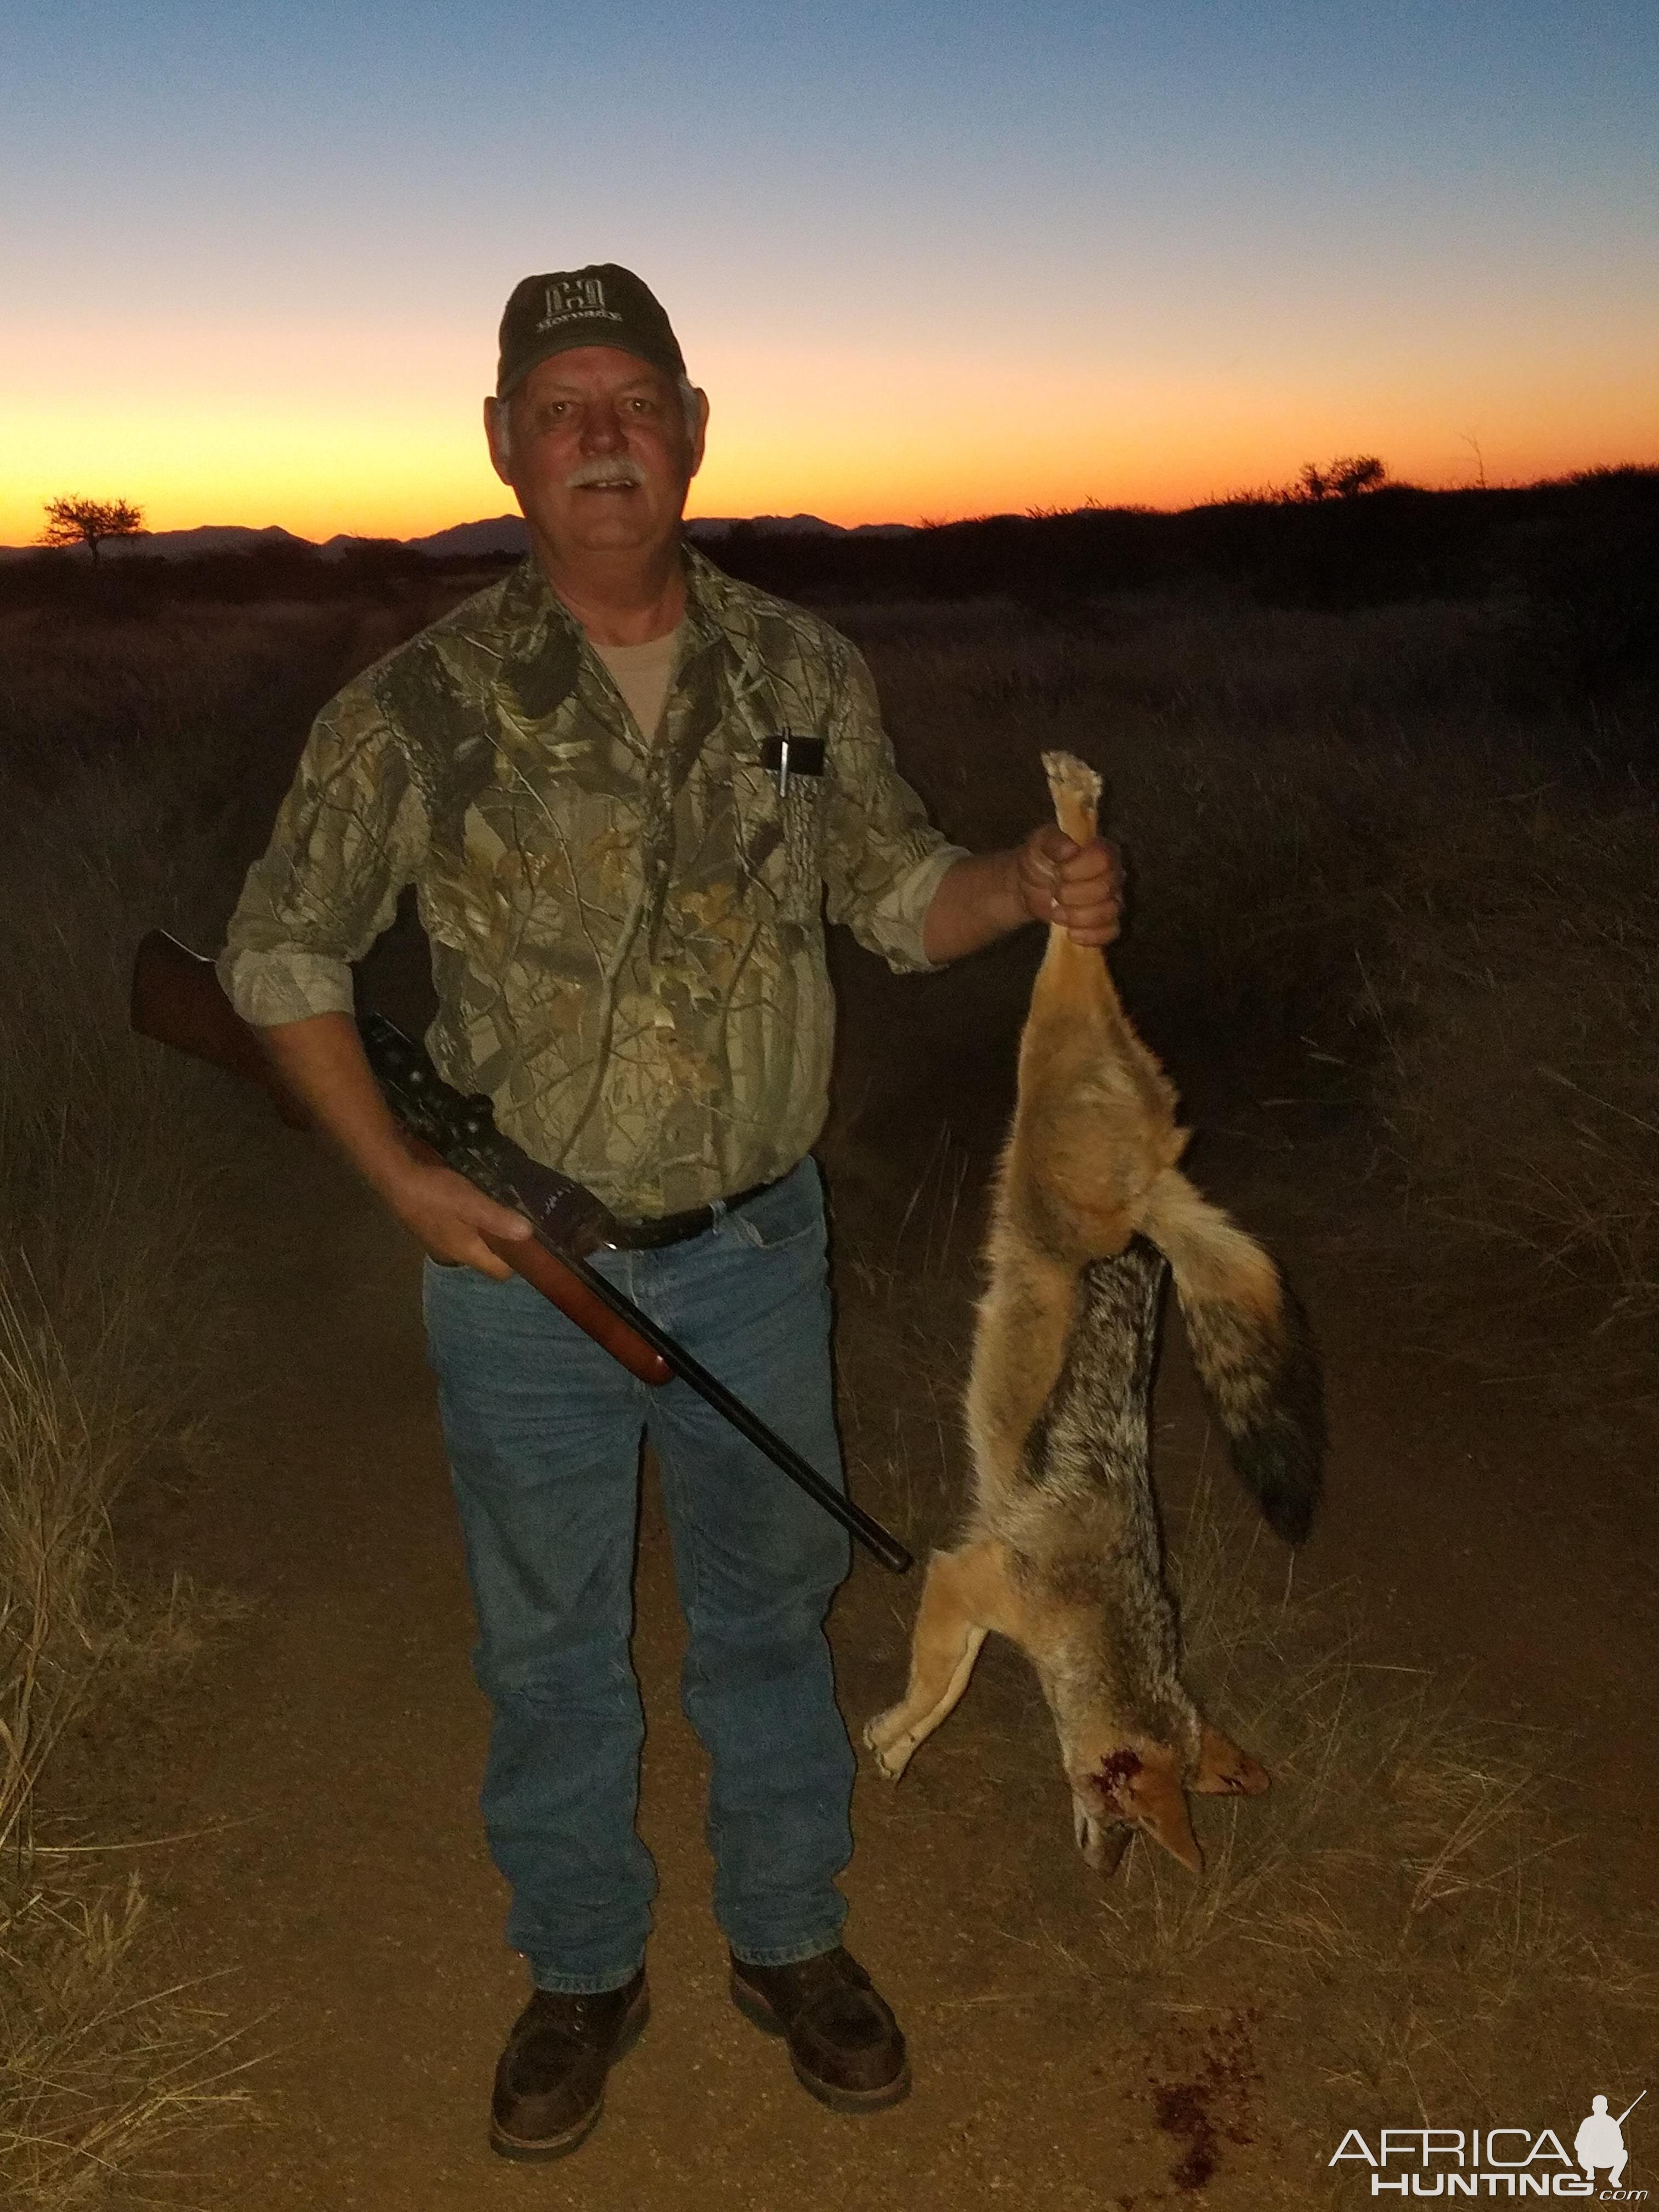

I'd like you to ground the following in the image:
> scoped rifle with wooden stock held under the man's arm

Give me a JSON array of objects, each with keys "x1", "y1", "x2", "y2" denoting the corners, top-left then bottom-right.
[{"x1": 133, "y1": 929, "x2": 913, "y2": 1575}]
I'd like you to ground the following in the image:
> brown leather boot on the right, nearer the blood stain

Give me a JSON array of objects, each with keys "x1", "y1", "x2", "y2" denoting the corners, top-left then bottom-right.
[{"x1": 732, "y1": 1944, "x2": 909, "y2": 2113}]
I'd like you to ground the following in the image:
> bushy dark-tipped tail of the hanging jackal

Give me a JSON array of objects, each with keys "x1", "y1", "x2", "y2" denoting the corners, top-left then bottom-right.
[{"x1": 1137, "y1": 1168, "x2": 1325, "y2": 1544}]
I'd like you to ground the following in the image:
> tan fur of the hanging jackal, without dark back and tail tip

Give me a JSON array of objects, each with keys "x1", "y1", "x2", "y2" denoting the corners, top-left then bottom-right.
[{"x1": 865, "y1": 754, "x2": 1309, "y2": 1871}]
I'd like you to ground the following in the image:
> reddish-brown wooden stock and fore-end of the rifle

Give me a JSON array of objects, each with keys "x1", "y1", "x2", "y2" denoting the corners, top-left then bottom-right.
[{"x1": 133, "y1": 929, "x2": 673, "y2": 1383}]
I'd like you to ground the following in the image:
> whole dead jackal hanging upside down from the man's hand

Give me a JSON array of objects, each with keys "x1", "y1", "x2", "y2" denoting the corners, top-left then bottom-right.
[{"x1": 865, "y1": 752, "x2": 1323, "y2": 1871}]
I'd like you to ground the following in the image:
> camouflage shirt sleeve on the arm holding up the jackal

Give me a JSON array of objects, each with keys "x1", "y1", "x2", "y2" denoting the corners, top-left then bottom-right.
[{"x1": 823, "y1": 650, "x2": 967, "y2": 973}]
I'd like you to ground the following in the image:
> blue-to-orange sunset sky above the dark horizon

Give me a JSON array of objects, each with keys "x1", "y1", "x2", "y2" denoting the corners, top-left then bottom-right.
[{"x1": 0, "y1": 0, "x2": 1659, "y2": 544}]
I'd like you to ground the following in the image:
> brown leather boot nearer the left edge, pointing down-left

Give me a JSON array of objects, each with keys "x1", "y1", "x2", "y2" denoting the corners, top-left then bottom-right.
[{"x1": 489, "y1": 1966, "x2": 650, "y2": 2159}]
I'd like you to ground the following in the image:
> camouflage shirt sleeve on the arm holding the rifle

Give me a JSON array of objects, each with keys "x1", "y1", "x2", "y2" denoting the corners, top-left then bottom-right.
[{"x1": 219, "y1": 684, "x2": 427, "y2": 1029}]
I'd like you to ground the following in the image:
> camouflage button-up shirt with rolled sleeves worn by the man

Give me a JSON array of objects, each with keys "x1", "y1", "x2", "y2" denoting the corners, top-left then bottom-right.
[{"x1": 219, "y1": 549, "x2": 960, "y2": 1217}]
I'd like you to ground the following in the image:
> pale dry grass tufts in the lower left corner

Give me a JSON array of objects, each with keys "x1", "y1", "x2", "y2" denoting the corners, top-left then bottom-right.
[{"x1": 0, "y1": 1252, "x2": 253, "y2": 2212}]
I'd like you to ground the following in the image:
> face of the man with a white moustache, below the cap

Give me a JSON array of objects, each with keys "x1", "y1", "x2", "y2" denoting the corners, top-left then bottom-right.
[{"x1": 484, "y1": 345, "x2": 708, "y2": 557}]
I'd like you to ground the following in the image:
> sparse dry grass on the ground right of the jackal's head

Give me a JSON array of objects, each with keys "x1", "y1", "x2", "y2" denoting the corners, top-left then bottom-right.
[{"x1": 1104, "y1": 1477, "x2": 1659, "y2": 2168}]
